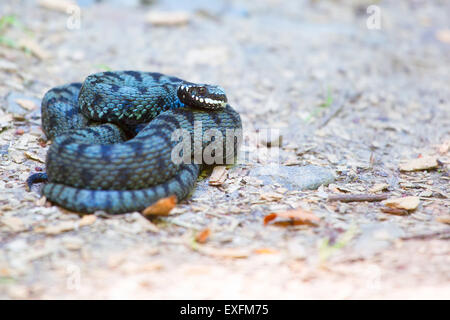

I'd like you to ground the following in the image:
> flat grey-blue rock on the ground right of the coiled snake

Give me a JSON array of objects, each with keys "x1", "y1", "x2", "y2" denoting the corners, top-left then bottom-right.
[{"x1": 250, "y1": 164, "x2": 335, "y2": 191}]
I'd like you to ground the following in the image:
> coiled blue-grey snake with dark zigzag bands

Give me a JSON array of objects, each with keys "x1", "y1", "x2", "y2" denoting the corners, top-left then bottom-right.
[{"x1": 27, "y1": 70, "x2": 242, "y2": 214}]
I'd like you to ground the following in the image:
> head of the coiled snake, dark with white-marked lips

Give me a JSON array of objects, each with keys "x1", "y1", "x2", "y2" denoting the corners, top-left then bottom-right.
[{"x1": 177, "y1": 83, "x2": 227, "y2": 110}]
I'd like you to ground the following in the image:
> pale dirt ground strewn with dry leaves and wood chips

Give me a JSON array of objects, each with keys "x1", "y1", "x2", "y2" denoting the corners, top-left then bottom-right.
[{"x1": 0, "y1": 0, "x2": 450, "y2": 299}]
